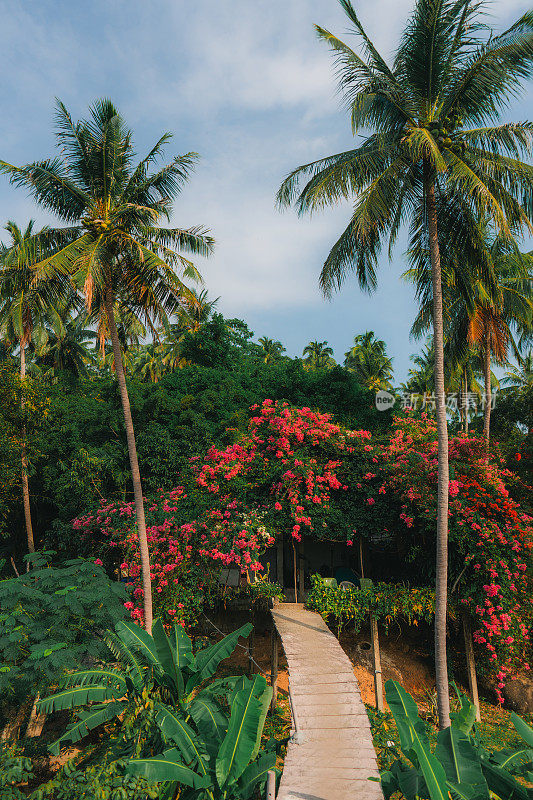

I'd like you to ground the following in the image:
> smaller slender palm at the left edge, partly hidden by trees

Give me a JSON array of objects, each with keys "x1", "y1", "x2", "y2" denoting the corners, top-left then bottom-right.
[{"x1": 0, "y1": 220, "x2": 69, "y2": 553}]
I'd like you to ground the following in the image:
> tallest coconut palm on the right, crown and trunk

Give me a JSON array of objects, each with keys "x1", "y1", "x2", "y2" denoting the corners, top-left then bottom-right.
[{"x1": 278, "y1": 0, "x2": 533, "y2": 728}]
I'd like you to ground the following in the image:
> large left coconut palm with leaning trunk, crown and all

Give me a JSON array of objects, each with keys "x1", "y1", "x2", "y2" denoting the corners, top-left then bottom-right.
[{"x1": 0, "y1": 99, "x2": 213, "y2": 630}]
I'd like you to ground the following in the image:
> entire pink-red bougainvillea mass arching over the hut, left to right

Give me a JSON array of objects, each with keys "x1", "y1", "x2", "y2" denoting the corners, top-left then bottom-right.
[{"x1": 75, "y1": 400, "x2": 533, "y2": 699}]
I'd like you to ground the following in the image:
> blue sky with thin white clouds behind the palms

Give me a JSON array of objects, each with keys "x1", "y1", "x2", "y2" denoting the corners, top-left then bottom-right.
[{"x1": 0, "y1": 0, "x2": 533, "y2": 382}]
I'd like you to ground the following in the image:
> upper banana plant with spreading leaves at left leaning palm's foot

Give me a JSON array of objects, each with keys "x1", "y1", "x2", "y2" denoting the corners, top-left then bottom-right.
[{"x1": 37, "y1": 620, "x2": 252, "y2": 758}]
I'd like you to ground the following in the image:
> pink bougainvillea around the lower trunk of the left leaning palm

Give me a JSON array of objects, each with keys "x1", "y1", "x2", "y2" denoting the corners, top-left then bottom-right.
[{"x1": 73, "y1": 487, "x2": 273, "y2": 625}]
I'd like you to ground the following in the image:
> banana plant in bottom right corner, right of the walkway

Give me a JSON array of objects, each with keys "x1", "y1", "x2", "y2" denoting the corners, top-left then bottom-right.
[{"x1": 381, "y1": 681, "x2": 533, "y2": 800}]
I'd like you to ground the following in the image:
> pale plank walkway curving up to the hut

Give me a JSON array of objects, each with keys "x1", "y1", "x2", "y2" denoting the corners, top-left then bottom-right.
[{"x1": 272, "y1": 603, "x2": 383, "y2": 800}]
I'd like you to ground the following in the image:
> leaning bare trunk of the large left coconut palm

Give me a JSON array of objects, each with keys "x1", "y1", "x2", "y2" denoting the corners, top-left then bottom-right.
[{"x1": 104, "y1": 290, "x2": 152, "y2": 633}]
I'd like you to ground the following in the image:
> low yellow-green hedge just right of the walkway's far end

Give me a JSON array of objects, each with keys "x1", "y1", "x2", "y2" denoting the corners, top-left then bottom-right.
[{"x1": 306, "y1": 575, "x2": 435, "y2": 632}]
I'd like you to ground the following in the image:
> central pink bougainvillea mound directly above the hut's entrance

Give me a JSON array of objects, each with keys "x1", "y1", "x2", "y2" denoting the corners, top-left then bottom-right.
[{"x1": 194, "y1": 400, "x2": 377, "y2": 541}]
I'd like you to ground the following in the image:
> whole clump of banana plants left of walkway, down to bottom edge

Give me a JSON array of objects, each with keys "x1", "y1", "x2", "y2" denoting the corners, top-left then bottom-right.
[{"x1": 39, "y1": 620, "x2": 276, "y2": 800}]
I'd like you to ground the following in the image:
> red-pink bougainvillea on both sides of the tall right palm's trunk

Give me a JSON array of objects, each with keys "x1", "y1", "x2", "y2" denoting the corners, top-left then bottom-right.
[{"x1": 382, "y1": 415, "x2": 533, "y2": 702}]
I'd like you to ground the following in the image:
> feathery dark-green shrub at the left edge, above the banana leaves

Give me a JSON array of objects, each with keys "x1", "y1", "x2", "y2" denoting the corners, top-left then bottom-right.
[{"x1": 0, "y1": 552, "x2": 125, "y2": 702}]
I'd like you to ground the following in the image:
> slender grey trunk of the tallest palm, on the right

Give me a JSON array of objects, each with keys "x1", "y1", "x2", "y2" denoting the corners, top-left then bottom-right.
[{"x1": 424, "y1": 170, "x2": 450, "y2": 730}]
